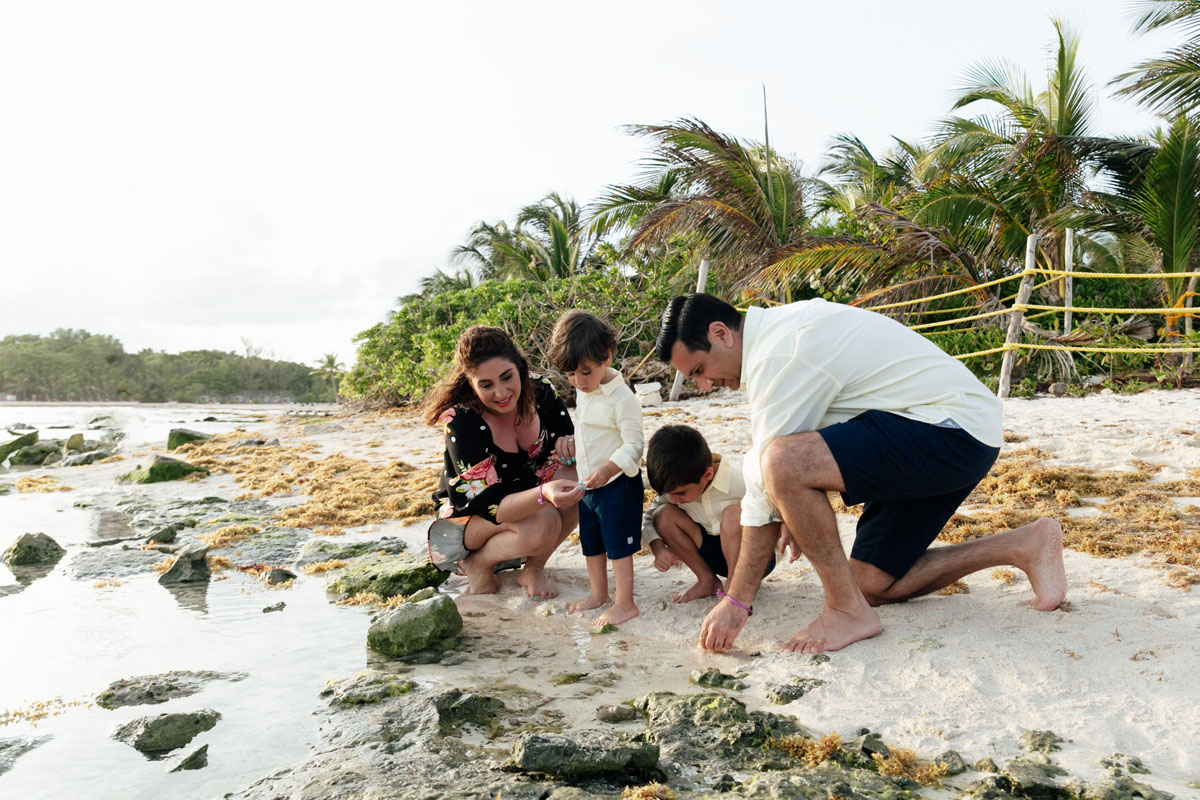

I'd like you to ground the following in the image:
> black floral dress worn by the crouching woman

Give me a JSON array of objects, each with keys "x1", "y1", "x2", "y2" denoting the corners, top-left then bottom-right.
[{"x1": 433, "y1": 378, "x2": 575, "y2": 523}]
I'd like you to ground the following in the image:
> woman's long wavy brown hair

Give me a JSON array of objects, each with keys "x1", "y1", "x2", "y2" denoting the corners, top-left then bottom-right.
[{"x1": 421, "y1": 325, "x2": 534, "y2": 425}]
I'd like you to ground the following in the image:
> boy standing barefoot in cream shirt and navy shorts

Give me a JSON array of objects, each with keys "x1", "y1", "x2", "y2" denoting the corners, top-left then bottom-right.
[{"x1": 550, "y1": 311, "x2": 646, "y2": 625}]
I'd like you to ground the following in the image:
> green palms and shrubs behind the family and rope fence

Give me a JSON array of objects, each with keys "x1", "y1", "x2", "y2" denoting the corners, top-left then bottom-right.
[{"x1": 350, "y1": 0, "x2": 1200, "y2": 404}]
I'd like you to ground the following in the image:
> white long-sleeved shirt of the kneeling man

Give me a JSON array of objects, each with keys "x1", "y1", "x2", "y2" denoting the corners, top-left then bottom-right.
[{"x1": 742, "y1": 300, "x2": 1003, "y2": 527}]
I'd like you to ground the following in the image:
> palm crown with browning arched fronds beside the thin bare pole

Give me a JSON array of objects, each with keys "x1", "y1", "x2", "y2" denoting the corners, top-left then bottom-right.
[{"x1": 592, "y1": 119, "x2": 812, "y2": 292}]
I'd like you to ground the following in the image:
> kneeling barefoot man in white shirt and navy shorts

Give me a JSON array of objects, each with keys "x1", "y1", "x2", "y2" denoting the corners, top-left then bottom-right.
[{"x1": 655, "y1": 294, "x2": 1067, "y2": 652}]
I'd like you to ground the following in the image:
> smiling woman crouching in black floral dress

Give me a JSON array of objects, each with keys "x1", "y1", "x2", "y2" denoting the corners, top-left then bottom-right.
[{"x1": 422, "y1": 325, "x2": 583, "y2": 600}]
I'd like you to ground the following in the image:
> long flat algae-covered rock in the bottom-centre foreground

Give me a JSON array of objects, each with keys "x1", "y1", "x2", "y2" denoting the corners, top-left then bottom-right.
[{"x1": 512, "y1": 733, "x2": 659, "y2": 778}]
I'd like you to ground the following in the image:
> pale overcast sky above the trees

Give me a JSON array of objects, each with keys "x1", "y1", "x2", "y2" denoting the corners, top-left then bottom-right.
[{"x1": 0, "y1": 0, "x2": 1176, "y2": 366}]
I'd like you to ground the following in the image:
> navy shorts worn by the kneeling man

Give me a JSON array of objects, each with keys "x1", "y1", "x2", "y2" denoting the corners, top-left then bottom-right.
[{"x1": 817, "y1": 411, "x2": 1000, "y2": 579}]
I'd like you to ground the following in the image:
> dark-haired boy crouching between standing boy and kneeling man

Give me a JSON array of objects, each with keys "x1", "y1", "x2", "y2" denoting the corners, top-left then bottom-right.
[{"x1": 642, "y1": 425, "x2": 777, "y2": 603}]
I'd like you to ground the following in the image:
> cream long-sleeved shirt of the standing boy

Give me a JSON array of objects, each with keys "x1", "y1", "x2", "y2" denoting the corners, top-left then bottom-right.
[{"x1": 575, "y1": 367, "x2": 646, "y2": 486}]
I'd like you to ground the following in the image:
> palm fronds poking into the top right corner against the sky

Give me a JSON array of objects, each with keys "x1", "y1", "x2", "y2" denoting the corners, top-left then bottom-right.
[{"x1": 1112, "y1": 0, "x2": 1200, "y2": 115}]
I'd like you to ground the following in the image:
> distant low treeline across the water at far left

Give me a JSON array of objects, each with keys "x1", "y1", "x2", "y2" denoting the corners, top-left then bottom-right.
[{"x1": 0, "y1": 329, "x2": 334, "y2": 403}]
